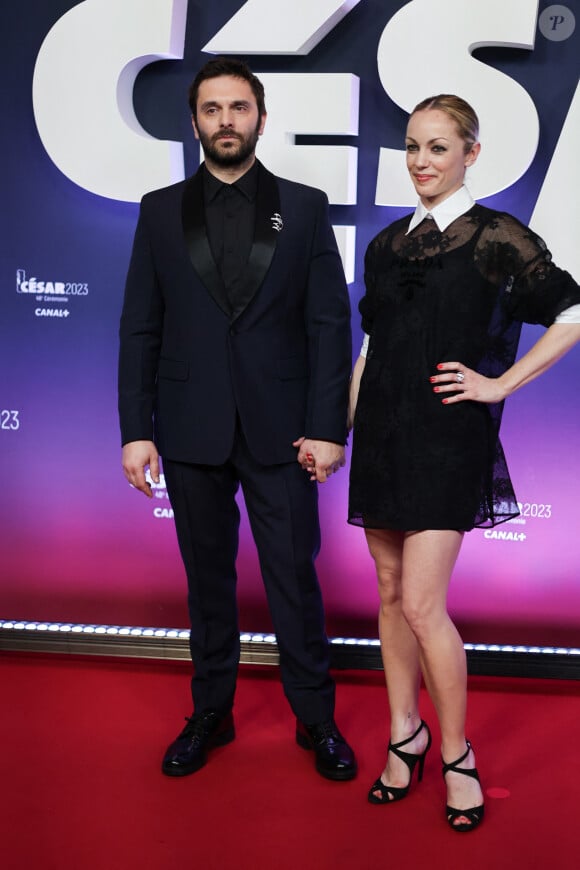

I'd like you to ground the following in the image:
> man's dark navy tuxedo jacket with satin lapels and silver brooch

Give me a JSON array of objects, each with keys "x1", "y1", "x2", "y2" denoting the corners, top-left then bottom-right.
[{"x1": 119, "y1": 165, "x2": 352, "y2": 465}]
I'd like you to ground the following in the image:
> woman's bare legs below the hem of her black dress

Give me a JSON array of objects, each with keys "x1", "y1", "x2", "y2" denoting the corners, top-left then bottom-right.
[{"x1": 366, "y1": 529, "x2": 482, "y2": 824}]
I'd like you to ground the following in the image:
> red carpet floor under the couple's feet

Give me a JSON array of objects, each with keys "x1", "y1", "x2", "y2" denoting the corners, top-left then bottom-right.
[{"x1": 0, "y1": 653, "x2": 580, "y2": 870}]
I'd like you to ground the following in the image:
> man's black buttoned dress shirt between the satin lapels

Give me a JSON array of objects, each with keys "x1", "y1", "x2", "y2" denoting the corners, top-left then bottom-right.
[{"x1": 203, "y1": 163, "x2": 258, "y2": 302}]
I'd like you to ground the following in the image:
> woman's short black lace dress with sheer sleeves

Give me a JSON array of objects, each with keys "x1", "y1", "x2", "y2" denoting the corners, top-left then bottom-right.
[{"x1": 349, "y1": 205, "x2": 580, "y2": 530}]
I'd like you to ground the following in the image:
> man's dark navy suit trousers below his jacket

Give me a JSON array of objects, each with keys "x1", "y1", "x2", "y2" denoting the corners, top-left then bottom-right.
[{"x1": 163, "y1": 426, "x2": 334, "y2": 724}]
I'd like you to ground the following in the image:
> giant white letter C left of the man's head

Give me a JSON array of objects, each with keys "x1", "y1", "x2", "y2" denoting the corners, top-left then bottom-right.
[{"x1": 32, "y1": 0, "x2": 187, "y2": 202}]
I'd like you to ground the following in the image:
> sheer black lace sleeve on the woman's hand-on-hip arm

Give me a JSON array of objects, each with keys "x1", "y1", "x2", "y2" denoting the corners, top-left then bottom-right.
[{"x1": 475, "y1": 213, "x2": 580, "y2": 326}]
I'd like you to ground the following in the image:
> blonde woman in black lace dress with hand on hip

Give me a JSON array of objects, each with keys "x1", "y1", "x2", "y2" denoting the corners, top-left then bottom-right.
[{"x1": 349, "y1": 94, "x2": 580, "y2": 832}]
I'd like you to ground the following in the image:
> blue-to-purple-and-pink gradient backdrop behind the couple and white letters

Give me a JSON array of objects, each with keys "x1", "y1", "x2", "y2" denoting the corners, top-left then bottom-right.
[{"x1": 0, "y1": 0, "x2": 580, "y2": 645}]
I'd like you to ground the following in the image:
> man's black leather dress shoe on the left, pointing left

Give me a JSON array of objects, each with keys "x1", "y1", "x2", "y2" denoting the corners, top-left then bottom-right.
[{"x1": 161, "y1": 712, "x2": 236, "y2": 776}]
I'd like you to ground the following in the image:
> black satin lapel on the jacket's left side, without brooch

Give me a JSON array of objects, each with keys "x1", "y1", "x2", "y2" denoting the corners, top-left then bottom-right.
[{"x1": 181, "y1": 170, "x2": 232, "y2": 317}]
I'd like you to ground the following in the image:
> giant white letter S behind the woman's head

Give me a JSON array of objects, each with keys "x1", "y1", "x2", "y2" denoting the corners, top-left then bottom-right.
[{"x1": 375, "y1": 0, "x2": 539, "y2": 206}]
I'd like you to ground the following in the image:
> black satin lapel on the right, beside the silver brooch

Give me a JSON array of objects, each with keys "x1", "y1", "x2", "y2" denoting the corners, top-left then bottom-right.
[{"x1": 232, "y1": 164, "x2": 283, "y2": 320}]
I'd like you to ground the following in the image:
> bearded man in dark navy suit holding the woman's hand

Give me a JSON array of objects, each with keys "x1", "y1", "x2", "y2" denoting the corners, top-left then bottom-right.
[{"x1": 119, "y1": 58, "x2": 356, "y2": 780}]
